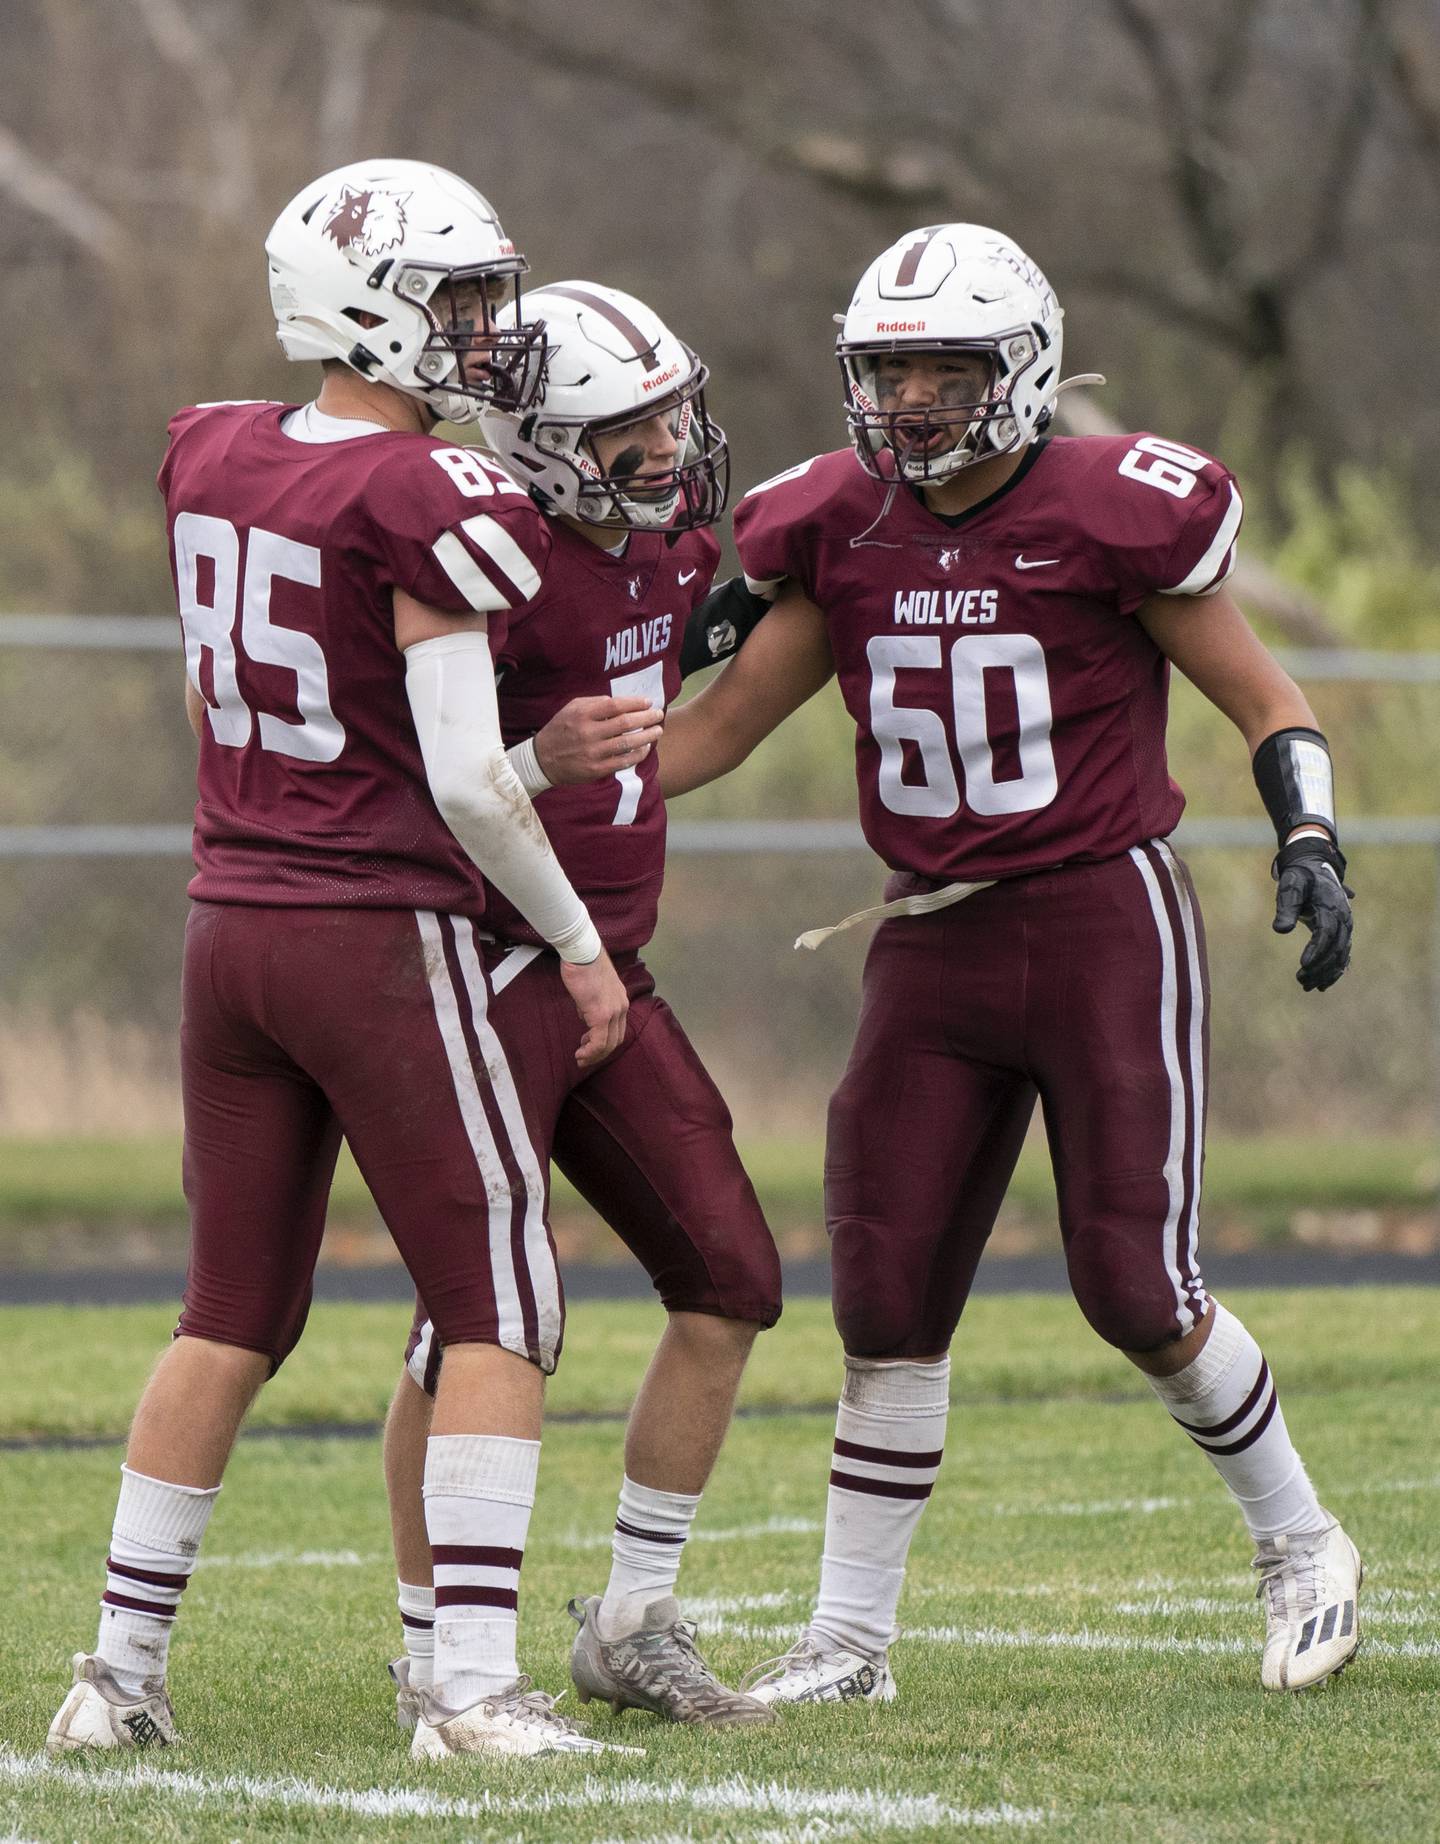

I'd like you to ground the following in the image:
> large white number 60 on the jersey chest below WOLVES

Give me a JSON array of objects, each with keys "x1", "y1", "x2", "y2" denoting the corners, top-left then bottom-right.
[{"x1": 865, "y1": 634, "x2": 1060, "y2": 819}]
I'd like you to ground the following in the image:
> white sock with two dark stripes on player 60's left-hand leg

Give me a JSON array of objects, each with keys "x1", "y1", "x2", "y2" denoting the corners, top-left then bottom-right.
[{"x1": 811, "y1": 1357, "x2": 950, "y2": 1652}]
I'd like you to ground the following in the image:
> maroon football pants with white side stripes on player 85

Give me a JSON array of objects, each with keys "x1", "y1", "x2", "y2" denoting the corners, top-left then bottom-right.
[{"x1": 179, "y1": 904, "x2": 578, "y2": 1370}]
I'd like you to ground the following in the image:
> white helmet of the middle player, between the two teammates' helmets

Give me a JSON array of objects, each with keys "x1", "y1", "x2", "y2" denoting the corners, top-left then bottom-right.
[{"x1": 479, "y1": 282, "x2": 730, "y2": 531}]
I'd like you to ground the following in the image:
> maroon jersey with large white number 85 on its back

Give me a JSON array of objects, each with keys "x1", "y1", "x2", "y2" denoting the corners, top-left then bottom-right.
[{"x1": 160, "y1": 404, "x2": 549, "y2": 916}]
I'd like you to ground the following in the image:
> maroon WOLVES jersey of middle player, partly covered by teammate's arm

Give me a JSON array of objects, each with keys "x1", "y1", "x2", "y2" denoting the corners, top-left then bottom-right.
[{"x1": 487, "y1": 524, "x2": 719, "y2": 953}]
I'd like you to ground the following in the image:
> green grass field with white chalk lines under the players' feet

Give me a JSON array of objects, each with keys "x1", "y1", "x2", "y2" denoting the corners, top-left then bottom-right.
[{"x1": 0, "y1": 1289, "x2": 1440, "y2": 1844}]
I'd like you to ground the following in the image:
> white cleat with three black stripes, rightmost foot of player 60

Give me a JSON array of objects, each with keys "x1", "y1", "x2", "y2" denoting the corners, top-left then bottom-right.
[{"x1": 1254, "y1": 1521, "x2": 1364, "y2": 1691}]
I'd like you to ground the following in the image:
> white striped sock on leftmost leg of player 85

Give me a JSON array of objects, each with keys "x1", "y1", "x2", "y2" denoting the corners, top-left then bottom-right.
[{"x1": 96, "y1": 1466, "x2": 219, "y2": 1696}]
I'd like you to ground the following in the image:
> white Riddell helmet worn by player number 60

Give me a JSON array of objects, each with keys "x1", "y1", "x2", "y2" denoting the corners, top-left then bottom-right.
[{"x1": 835, "y1": 225, "x2": 1079, "y2": 481}]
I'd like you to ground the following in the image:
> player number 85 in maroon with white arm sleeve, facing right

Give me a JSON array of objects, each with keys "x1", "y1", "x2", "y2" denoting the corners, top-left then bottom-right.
[{"x1": 48, "y1": 160, "x2": 643, "y2": 1755}]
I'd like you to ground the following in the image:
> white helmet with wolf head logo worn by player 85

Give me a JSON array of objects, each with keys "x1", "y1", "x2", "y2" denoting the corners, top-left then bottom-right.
[{"x1": 266, "y1": 160, "x2": 546, "y2": 422}]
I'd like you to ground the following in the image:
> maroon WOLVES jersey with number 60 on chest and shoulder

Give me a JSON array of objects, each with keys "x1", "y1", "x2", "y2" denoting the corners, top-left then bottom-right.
[{"x1": 734, "y1": 435, "x2": 1243, "y2": 881}]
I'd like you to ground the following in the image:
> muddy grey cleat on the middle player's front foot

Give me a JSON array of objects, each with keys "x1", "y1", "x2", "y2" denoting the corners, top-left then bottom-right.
[{"x1": 570, "y1": 1595, "x2": 774, "y2": 1728}]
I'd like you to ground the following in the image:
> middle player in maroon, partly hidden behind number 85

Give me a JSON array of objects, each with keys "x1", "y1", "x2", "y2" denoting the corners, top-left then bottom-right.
[{"x1": 376, "y1": 282, "x2": 780, "y2": 1726}]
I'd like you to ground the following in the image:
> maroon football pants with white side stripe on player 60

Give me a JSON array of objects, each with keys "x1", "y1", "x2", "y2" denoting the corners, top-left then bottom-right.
[{"x1": 826, "y1": 843, "x2": 1210, "y2": 1357}]
